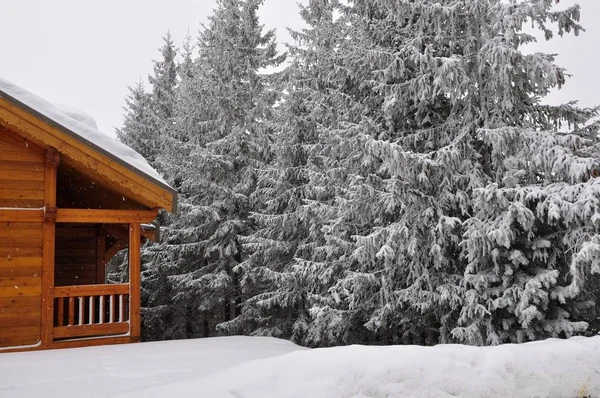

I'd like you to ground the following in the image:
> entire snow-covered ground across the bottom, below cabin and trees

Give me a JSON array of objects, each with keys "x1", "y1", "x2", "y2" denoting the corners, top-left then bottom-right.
[{"x1": 0, "y1": 337, "x2": 600, "y2": 398}]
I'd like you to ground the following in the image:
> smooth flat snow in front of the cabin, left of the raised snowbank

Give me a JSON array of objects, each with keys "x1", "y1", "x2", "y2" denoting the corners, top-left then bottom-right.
[{"x1": 0, "y1": 337, "x2": 301, "y2": 398}]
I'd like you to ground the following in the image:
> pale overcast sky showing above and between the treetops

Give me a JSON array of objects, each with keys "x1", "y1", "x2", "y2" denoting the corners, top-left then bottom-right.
[{"x1": 0, "y1": 0, "x2": 600, "y2": 132}]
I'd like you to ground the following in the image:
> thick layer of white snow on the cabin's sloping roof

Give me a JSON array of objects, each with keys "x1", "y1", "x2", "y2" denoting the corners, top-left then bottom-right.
[{"x1": 0, "y1": 78, "x2": 172, "y2": 190}]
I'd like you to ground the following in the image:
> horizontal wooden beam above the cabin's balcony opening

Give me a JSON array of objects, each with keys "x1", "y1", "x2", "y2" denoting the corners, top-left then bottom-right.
[{"x1": 56, "y1": 209, "x2": 158, "y2": 224}]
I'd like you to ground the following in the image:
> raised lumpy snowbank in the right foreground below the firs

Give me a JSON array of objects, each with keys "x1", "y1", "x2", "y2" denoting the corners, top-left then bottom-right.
[{"x1": 125, "y1": 337, "x2": 600, "y2": 398}]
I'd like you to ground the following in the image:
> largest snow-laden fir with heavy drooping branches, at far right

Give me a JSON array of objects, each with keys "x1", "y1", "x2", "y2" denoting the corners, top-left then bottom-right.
[{"x1": 332, "y1": 0, "x2": 598, "y2": 344}]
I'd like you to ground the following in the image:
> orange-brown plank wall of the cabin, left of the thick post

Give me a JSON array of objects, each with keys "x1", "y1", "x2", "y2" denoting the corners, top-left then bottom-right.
[{"x1": 0, "y1": 128, "x2": 46, "y2": 348}]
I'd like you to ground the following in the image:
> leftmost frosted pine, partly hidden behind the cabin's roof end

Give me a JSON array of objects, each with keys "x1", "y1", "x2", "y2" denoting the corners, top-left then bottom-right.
[{"x1": 117, "y1": 33, "x2": 186, "y2": 340}]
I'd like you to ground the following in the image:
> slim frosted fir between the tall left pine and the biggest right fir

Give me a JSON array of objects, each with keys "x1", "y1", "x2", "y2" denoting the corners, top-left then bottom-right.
[{"x1": 221, "y1": 1, "x2": 350, "y2": 344}]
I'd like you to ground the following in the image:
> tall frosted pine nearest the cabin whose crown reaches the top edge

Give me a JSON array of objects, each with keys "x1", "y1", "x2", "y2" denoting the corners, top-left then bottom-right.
[{"x1": 160, "y1": 0, "x2": 284, "y2": 334}]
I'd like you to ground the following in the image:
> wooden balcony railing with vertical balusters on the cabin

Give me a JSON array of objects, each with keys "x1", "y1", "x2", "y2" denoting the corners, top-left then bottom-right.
[{"x1": 53, "y1": 283, "x2": 130, "y2": 339}]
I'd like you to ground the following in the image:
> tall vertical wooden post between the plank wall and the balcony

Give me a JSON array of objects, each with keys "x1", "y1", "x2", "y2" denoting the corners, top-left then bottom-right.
[{"x1": 41, "y1": 148, "x2": 60, "y2": 347}]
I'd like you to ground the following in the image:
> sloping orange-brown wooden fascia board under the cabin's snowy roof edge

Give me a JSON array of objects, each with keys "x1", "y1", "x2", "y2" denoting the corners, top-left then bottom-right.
[{"x1": 0, "y1": 98, "x2": 174, "y2": 211}]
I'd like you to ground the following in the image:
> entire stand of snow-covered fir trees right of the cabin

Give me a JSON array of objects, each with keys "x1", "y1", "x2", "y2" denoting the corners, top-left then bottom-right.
[{"x1": 117, "y1": 0, "x2": 600, "y2": 346}]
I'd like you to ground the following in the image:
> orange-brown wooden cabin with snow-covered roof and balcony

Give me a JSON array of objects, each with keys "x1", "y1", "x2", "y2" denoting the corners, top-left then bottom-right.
[{"x1": 0, "y1": 79, "x2": 176, "y2": 353}]
